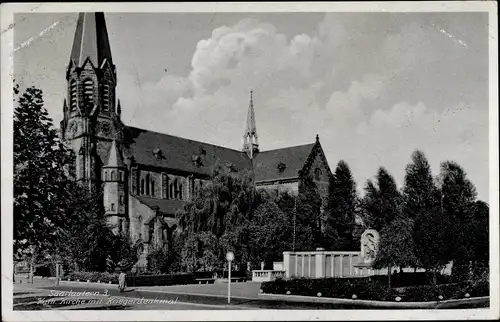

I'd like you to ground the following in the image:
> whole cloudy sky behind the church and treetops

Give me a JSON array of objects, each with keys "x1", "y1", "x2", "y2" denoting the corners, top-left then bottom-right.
[{"x1": 14, "y1": 13, "x2": 489, "y2": 201}]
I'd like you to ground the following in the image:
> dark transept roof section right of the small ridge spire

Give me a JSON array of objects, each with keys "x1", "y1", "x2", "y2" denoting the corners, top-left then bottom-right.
[{"x1": 253, "y1": 143, "x2": 315, "y2": 183}]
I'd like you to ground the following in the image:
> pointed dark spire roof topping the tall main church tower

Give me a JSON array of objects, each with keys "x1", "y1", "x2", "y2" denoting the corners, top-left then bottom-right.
[{"x1": 70, "y1": 12, "x2": 113, "y2": 68}]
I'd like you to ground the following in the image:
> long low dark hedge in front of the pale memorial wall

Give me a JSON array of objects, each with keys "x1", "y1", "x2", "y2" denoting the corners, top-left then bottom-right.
[{"x1": 261, "y1": 277, "x2": 489, "y2": 302}]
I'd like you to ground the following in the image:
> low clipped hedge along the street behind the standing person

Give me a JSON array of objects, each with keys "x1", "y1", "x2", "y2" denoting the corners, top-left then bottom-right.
[{"x1": 63, "y1": 272, "x2": 196, "y2": 286}]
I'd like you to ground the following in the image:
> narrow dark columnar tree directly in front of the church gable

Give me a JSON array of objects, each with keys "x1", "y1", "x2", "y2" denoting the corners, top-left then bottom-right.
[{"x1": 294, "y1": 176, "x2": 321, "y2": 250}]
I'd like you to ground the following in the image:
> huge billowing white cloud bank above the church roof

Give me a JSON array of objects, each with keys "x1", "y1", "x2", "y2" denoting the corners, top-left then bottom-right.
[{"x1": 112, "y1": 15, "x2": 488, "y2": 200}]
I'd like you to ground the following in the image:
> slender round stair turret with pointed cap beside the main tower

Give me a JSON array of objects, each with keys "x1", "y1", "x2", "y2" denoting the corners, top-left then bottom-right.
[{"x1": 102, "y1": 140, "x2": 128, "y2": 233}]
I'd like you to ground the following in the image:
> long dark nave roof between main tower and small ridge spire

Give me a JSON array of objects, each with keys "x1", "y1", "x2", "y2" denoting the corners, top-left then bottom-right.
[{"x1": 124, "y1": 126, "x2": 252, "y2": 176}]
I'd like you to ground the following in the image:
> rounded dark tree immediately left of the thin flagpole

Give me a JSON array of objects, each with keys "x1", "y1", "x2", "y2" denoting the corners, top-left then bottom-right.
[{"x1": 250, "y1": 200, "x2": 293, "y2": 265}]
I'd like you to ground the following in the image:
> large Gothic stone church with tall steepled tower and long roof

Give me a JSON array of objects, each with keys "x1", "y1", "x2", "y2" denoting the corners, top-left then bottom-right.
[{"x1": 60, "y1": 13, "x2": 332, "y2": 265}]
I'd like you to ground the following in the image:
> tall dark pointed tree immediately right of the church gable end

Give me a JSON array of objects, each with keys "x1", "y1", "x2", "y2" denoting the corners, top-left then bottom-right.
[{"x1": 325, "y1": 160, "x2": 359, "y2": 250}]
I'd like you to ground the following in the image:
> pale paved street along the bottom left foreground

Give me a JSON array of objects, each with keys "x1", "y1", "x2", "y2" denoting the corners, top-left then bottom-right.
[{"x1": 10, "y1": 280, "x2": 356, "y2": 310}]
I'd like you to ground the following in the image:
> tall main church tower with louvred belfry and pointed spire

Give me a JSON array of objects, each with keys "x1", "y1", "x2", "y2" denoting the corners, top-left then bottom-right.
[{"x1": 61, "y1": 12, "x2": 122, "y2": 188}]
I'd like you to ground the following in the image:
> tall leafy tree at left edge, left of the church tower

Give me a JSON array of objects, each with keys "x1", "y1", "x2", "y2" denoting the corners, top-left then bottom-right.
[{"x1": 13, "y1": 86, "x2": 73, "y2": 275}]
